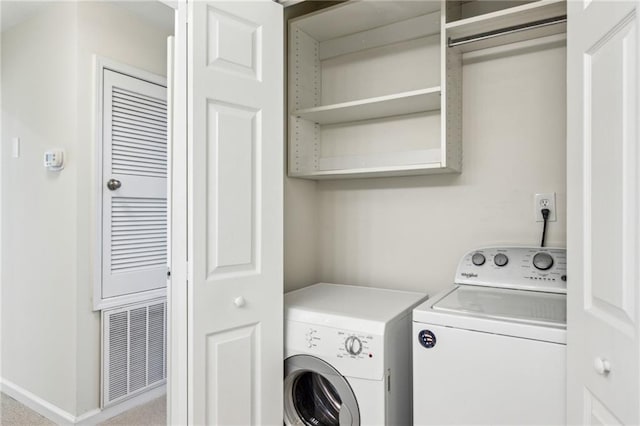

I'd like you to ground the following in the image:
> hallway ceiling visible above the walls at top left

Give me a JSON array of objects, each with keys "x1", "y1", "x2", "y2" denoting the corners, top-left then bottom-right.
[{"x1": 0, "y1": 0, "x2": 174, "y2": 32}]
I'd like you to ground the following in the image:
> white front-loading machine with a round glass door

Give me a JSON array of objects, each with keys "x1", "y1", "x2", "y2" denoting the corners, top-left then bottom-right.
[{"x1": 284, "y1": 283, "x2": 427, "y2": 426}]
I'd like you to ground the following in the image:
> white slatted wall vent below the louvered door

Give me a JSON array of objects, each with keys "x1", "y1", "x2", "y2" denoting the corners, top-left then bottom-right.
[{"x1": 102, "y1": 298, "x2": 167, "y2": 407}]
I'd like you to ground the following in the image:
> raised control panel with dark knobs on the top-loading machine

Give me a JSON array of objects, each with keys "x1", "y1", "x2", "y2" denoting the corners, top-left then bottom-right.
[{"x1": 455, "y1": 247, "x2": 567, "y2": 293}]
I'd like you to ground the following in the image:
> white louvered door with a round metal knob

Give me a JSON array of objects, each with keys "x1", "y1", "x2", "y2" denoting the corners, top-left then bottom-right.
[{"x1": 102, "y1": 69, "x2": 167, "y2": 300}]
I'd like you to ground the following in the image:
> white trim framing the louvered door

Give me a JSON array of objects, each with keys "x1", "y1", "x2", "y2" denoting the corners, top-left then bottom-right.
[{"x1": 92, "y1": 54, "x2": 168, "y2": 311}]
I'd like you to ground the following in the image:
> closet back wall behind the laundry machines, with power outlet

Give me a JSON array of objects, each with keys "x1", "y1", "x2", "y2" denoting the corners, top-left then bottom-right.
[{"x1": 285, "y1": 38, "x2": 566, "y2": 294}]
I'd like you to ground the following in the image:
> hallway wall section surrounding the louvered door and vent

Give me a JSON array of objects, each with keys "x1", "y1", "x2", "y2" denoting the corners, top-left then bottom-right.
[{"x1": 76, "y1": 1, "x2": 171, "y2": 414}]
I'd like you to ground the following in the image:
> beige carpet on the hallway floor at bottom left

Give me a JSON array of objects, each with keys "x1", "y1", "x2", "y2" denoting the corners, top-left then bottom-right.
[{"x1": 0, "y1": 393, "x2": 167, "y2": 426}]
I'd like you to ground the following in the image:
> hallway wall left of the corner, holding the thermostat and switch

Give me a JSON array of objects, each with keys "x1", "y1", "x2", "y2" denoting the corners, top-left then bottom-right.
[{"x1": 1, "y1": 3, "x2": 78, "y2": 413}]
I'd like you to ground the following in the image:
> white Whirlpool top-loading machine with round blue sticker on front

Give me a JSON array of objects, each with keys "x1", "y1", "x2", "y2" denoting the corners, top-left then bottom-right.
[{"x1": 413, "y1": 247, "x2": 567, "y2": 425}]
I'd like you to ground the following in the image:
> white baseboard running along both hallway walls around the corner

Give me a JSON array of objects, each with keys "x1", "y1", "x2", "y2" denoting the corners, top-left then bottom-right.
[{"x1": 0, "y1": 378, "x2": 167, "y2": 425}]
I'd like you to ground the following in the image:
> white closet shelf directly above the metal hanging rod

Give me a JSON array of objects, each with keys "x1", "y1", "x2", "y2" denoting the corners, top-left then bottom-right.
[{"x1": 445, "y1": 0, "x2": 567, "y2": 45}]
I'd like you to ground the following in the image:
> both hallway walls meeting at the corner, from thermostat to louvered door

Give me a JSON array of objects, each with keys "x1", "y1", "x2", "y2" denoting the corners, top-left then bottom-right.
[{"x1": 1, "y1": 1, "x2": 169, "y2": 416}]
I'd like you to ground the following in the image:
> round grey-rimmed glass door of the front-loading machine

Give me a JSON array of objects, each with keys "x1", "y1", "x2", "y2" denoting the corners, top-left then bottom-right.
[{"x1": 284, "y1": 355, "x2": 360, "y2": 426}]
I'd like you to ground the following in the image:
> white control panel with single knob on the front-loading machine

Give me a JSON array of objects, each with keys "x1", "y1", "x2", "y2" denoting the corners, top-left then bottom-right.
[{"x1": 285, "y1": 320, "x2": 384, "y2": 380}]
